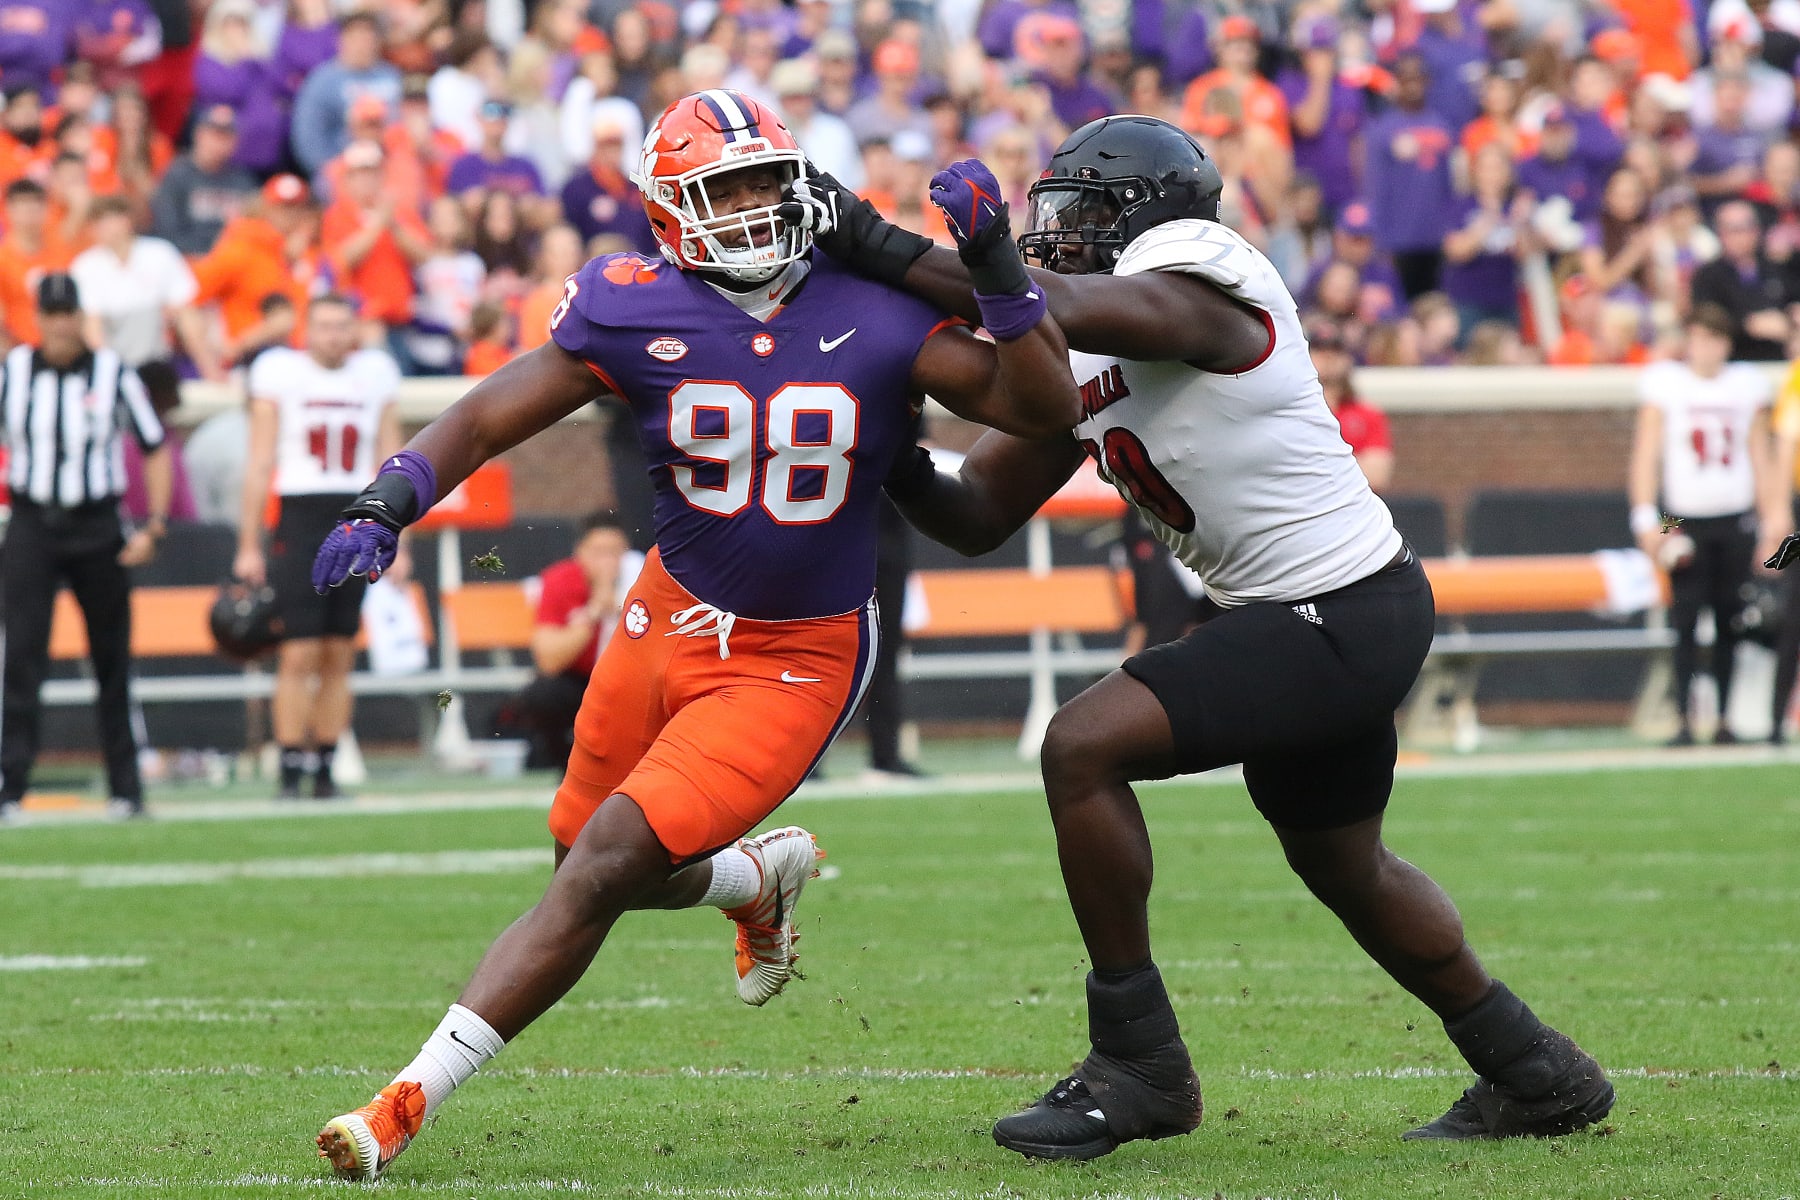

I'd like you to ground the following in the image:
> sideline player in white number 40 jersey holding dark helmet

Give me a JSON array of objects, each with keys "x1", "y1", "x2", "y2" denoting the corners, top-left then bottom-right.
[{"x1": 232, "y1": 295, "x2": 401, "y2": 799}]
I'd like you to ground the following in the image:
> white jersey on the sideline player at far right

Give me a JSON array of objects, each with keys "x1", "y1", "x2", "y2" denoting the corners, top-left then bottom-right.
[{"x1": 1638, "y1": 362, "x2": 1773, "y2": 516}]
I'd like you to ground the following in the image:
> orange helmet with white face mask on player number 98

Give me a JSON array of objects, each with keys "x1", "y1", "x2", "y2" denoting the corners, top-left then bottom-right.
[{"x1": 632, "y1": 88, "x2": 812, "y2": 282}]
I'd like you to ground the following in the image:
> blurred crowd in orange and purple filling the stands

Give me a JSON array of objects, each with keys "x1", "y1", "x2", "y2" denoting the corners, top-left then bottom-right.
[{"x1": 0, "y1": 0, "x2": 1800, "y2": 378}]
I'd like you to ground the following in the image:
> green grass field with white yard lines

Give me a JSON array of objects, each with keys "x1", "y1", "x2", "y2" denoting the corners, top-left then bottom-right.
[{"x1": 0, "y1": 766, "x2": 1800, "y2": 1200}]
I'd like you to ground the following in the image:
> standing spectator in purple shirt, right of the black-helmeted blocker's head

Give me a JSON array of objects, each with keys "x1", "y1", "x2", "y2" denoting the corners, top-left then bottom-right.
[{"x1": 1363, "y1": 54, "x2": 1454, "y2": 300}]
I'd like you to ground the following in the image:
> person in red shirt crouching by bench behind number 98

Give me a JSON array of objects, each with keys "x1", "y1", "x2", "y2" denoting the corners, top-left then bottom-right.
[{"x1": 495, "y1": 513, "x2": 641, "y2": 770}]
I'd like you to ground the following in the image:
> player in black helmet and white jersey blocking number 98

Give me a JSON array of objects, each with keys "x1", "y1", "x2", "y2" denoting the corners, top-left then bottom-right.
[{"x1": 796, "y1": 117, "x2": 1613, "y2": 1159}]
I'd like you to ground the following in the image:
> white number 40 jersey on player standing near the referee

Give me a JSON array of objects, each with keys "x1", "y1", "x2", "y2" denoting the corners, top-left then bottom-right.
[{"x1": 250, "y1": 347, "x2": 400, "y2": 497}]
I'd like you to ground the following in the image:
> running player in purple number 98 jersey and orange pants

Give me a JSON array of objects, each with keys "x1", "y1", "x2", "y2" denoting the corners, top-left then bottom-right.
[{"x1": 313, "y1": 90, "x2": 1080, "y2": 1178}]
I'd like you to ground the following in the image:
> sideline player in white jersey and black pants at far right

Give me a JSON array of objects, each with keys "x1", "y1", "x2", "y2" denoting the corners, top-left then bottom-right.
[{"x1": 1629, "y1": 305, "x2": 1789, "y2": 745}]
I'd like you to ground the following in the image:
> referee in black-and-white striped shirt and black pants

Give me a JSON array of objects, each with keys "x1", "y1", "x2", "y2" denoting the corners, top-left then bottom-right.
[{"x1": 0, "y1": 273, "x2": 175, "y2": 820}]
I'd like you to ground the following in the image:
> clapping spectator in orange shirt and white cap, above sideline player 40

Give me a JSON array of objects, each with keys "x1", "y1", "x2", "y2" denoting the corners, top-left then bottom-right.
[{"x1": 320, "y1": 142, "x2": 430, "y2": 362}]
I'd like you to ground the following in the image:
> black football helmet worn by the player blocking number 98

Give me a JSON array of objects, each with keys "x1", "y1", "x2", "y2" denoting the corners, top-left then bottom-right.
[{"x1": 1019, "y1": 117, "x2": 1224, "y2": 275}]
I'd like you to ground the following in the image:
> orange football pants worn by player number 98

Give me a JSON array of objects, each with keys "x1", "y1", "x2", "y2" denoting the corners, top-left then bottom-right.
[{"x1": 549, "y1": 551, "x2": 875, "y2": 862}]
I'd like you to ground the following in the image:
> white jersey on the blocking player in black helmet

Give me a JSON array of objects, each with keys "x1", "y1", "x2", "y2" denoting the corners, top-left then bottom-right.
[{"x1": 1069, "y1": 219, "x2": 1400, "y2": 608}]
